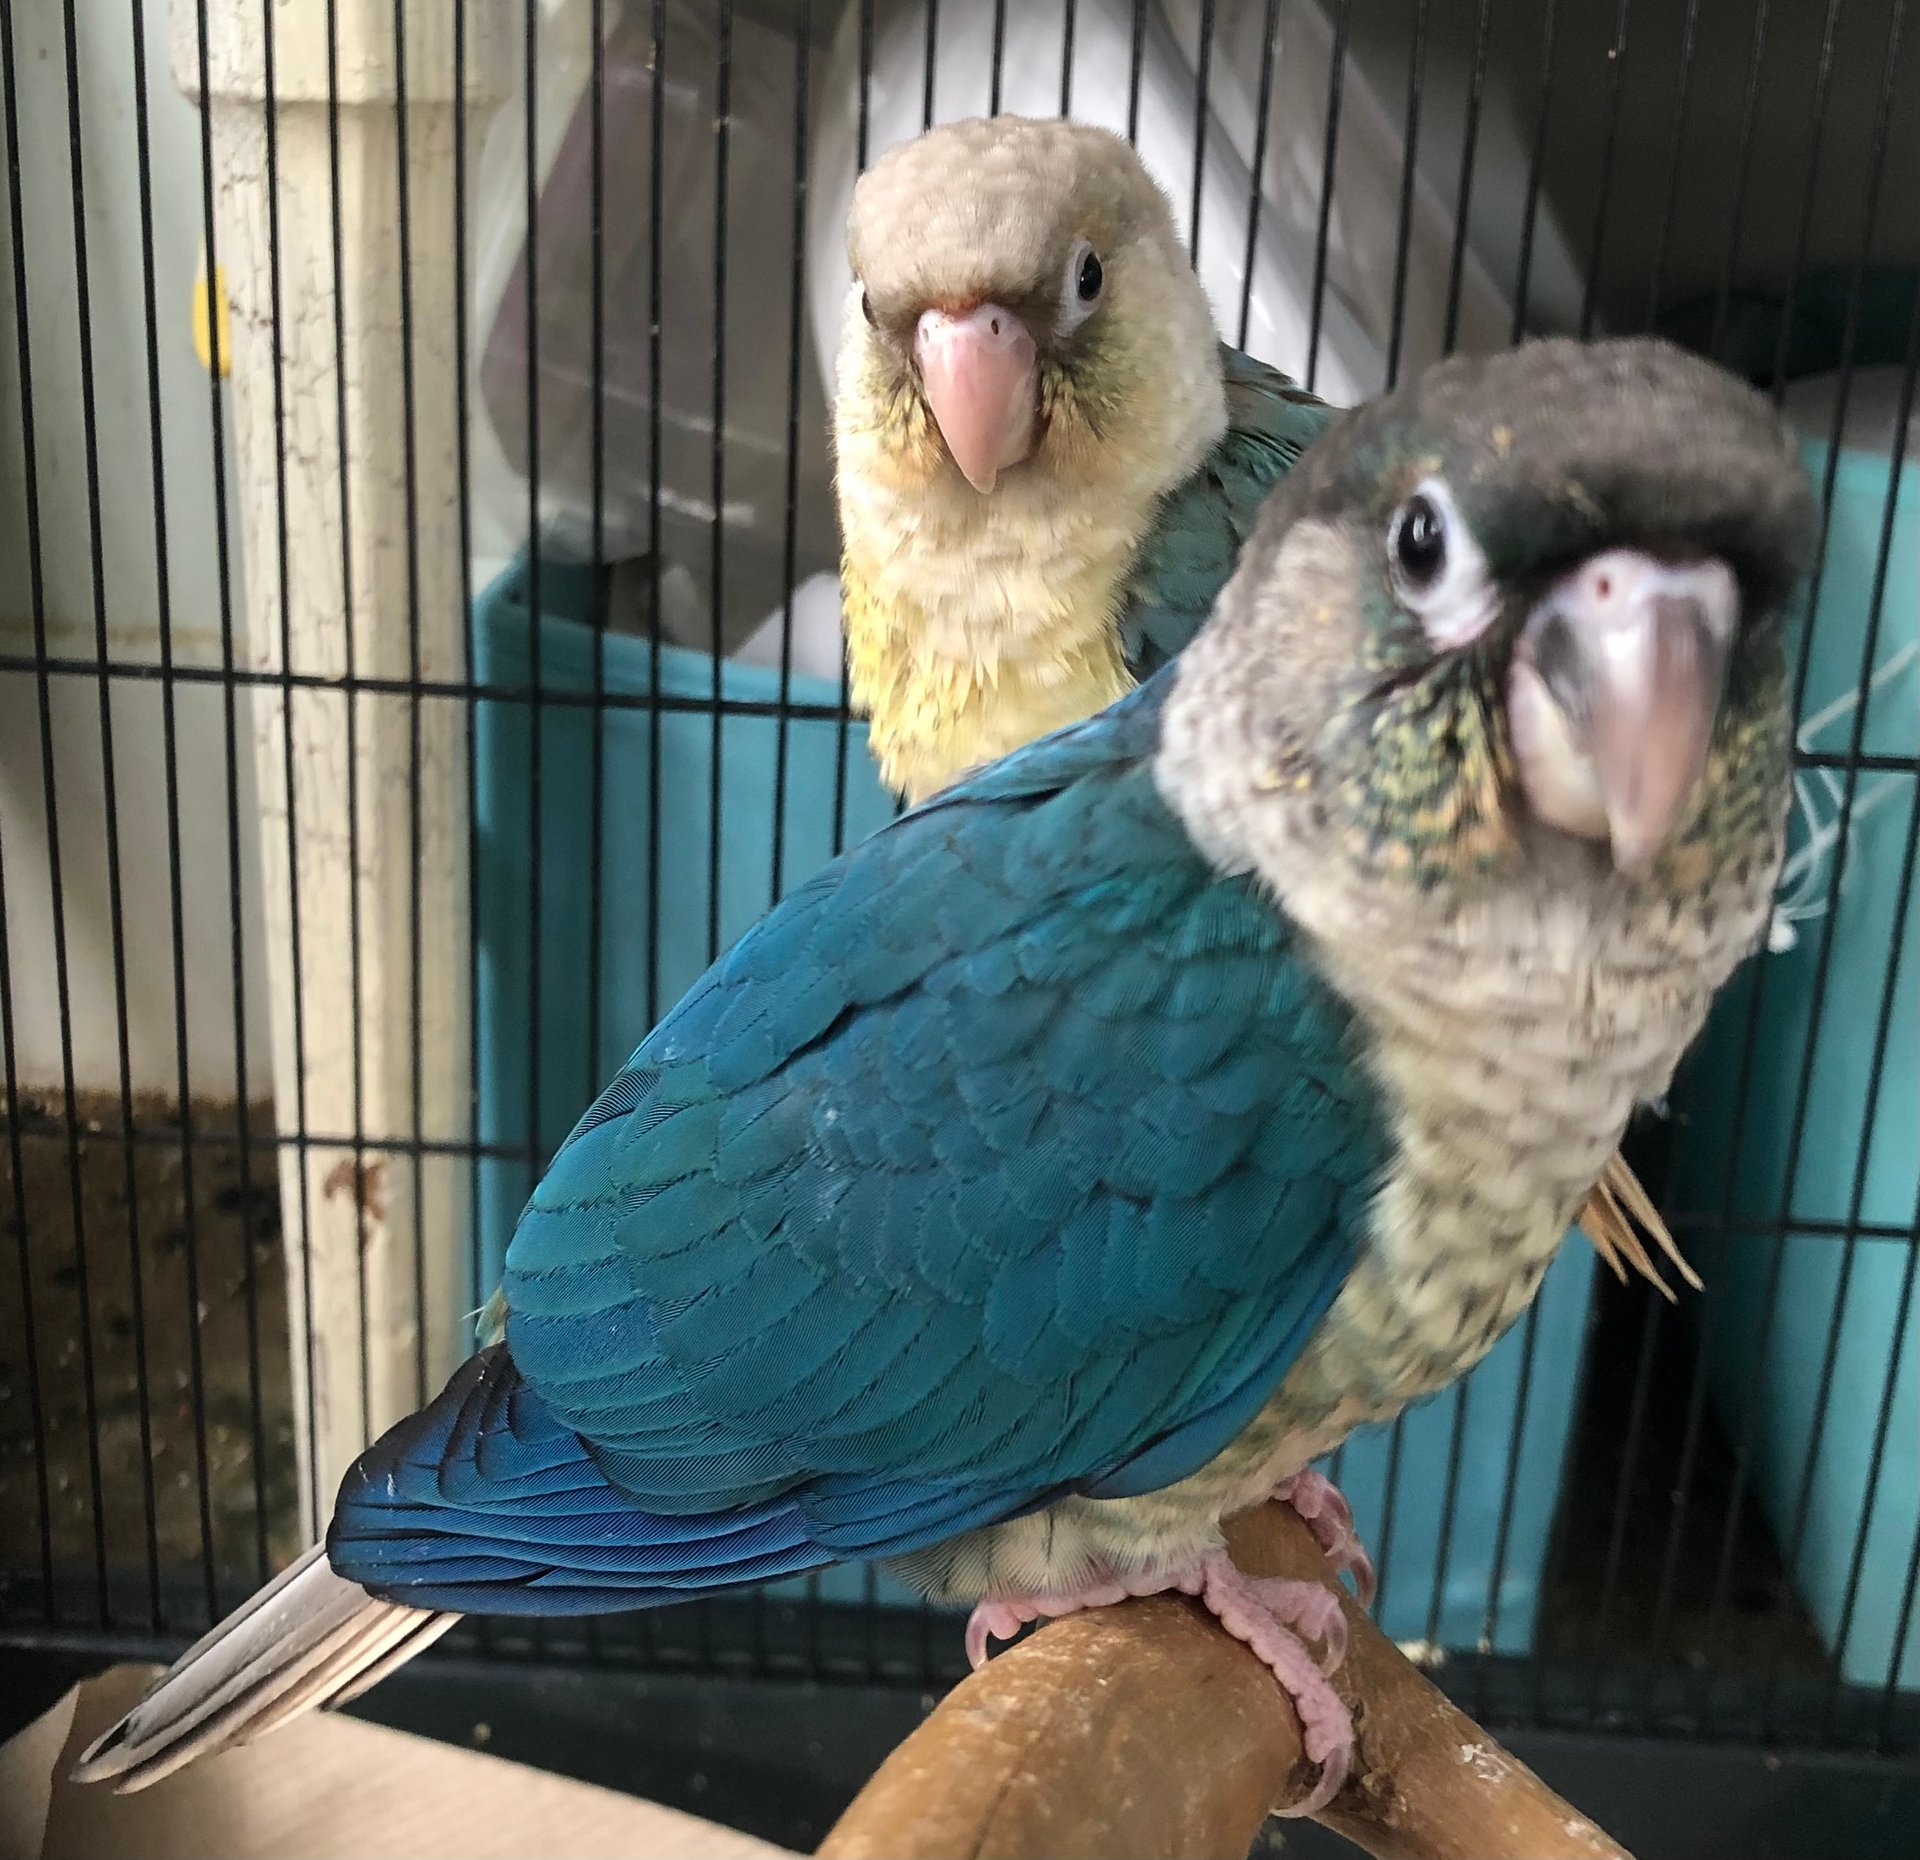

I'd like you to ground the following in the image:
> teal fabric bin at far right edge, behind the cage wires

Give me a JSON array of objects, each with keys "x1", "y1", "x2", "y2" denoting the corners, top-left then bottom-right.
[{"x1": 1674, "y1": 431, "x2": 1920, "y2": 1687}]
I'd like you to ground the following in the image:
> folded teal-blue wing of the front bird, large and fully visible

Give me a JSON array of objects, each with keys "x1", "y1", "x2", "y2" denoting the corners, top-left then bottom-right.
[{"x1": 330, "y1": 680, "x2": 1384, "y2": 1607}]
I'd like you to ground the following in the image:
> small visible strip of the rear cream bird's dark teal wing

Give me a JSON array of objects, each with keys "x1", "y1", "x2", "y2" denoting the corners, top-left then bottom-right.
[{"x1": 1119, "y1": 344, "x2": 1334, "y2": 678}]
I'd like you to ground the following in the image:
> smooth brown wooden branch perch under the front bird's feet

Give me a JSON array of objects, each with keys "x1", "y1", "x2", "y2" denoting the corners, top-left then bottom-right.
[{"x1": 820, "y1": 1505, "x2": 1626, "y2": 1860}]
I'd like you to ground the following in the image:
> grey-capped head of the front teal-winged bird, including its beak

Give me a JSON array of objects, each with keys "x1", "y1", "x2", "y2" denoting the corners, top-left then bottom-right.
[{"x1": 1185, "y1": 340, "x2": 1814, "y2": 902}]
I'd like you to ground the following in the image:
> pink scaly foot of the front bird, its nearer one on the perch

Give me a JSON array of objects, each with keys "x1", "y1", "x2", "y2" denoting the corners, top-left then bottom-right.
[{"x1": 966, "y1": 1543, "x2": 1354, "y2": 1816}]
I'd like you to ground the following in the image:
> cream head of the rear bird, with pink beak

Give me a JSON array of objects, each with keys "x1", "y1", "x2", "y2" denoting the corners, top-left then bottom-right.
[{"x1": 835, "y1": 117, "x2": 1225, "y2": 507}]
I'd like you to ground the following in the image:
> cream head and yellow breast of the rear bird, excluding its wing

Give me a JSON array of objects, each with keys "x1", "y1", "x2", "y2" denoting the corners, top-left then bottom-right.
[{"x1": 833, "y1": 117, "x2": 1227, "y2": 800}]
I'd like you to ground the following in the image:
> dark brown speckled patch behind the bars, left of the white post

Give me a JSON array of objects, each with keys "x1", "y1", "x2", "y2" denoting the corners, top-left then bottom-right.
[{"x1": 0, "y1": 1092, "x2": 300, "y2": 1622}]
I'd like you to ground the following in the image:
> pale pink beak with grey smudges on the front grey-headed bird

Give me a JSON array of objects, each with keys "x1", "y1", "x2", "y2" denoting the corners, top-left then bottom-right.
[{"x1": 1507, "y1": 549, "x2": 1740, "y2": 873}]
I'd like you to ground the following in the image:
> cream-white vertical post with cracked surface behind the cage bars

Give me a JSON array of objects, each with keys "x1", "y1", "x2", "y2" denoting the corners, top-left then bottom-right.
[{"x1": 171, "y1": 0, "x2": 511, "y2": 1536}]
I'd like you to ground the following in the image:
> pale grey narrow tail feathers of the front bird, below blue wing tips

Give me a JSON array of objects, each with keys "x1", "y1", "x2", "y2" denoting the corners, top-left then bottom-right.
[{"x1": 73, "y1": 1543, "x2": 459, "y2": 1791}]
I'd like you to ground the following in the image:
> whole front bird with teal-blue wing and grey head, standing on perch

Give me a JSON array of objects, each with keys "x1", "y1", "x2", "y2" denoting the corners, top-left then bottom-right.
[{"x1": 79, "y1": 342, "x2": 1812, "y2": 1808}]
